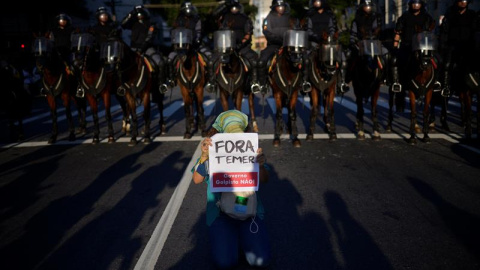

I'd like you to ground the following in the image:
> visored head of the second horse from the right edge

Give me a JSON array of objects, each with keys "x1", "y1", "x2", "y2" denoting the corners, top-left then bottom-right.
[{"x1": 412, "y1": 31, "x2": 438, "y2": 70}]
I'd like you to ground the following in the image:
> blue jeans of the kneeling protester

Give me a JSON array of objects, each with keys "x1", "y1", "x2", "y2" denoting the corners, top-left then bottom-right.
[{"x1": 208, "y1": 213, "x2": 270, "y2": 269}]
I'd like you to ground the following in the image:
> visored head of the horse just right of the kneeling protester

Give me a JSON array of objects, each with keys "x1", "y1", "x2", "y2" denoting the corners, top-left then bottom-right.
[{"x1": 283, "y1": 29, "x2": 308, "y2": 64}]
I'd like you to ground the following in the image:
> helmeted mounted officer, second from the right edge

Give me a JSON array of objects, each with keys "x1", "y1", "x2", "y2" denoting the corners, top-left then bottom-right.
[{"x1": 392, "y1": 0, "x2": 441, "y2": 112}]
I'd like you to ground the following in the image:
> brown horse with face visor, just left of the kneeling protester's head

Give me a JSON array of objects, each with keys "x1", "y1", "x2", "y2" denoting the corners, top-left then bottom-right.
[{"x1": 172, "y1": 27, "x2": 207, "y2": 139}]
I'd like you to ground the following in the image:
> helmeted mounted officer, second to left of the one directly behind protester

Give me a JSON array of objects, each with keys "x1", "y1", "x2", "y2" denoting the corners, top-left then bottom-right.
[{"x1": 117, "y1": 5, "x2": 166, "y2": 95}]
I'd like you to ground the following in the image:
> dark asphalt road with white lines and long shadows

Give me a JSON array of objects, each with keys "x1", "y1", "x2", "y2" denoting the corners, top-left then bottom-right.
[{"x1": 0, "y1": 87, "x2": 480, "y2": 269}]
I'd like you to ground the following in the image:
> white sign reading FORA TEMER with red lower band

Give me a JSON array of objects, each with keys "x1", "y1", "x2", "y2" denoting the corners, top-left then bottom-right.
[{"x1": 209, "y1": 133, "x2": 259, "y2": 192}]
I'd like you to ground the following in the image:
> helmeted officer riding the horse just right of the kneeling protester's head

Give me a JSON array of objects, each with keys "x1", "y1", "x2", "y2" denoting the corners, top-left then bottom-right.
[{"x1": 257, "y1": 0, "x2": 312, "y2": 93}]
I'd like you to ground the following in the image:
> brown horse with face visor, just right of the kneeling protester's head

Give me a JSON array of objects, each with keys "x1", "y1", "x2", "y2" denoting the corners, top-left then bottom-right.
[{"x1": 268, "y1": 29, "x2": 308, "y2": 147}]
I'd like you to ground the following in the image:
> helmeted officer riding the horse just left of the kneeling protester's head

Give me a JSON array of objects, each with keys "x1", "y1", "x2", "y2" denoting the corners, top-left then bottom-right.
[{"x1": 167, "y1": 1, "x2": 212, "y2": 92}]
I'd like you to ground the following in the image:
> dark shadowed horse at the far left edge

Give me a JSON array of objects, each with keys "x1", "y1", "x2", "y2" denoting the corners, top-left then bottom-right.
[{"x1": 0, "y1": 60, "x2": 32, "y2": 141}]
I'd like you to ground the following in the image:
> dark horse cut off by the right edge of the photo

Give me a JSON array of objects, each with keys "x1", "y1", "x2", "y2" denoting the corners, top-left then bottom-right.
[{"x1": 460, "y1": 32, "x2": 480, "y2": 140}]
